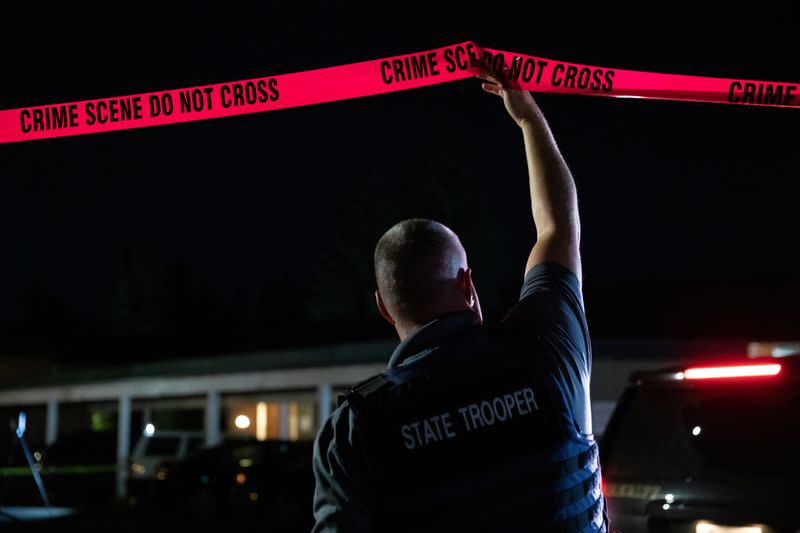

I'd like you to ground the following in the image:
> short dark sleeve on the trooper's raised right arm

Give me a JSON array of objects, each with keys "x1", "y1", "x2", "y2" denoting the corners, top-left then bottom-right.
[{"x1": 504, "y1": 263, "x2": 592, "y2": 433}]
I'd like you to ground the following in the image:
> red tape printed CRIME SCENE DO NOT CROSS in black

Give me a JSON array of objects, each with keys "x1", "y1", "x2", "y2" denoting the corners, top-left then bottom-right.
[{"x1": 0, "y1": 42, "x2": 800, "y2": 143}]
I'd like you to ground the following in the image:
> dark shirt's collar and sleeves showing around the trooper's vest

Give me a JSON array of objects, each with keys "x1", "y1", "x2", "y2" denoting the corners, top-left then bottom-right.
[{"x1": 313, "y1": 263, "x2": 592, "y2": 532}]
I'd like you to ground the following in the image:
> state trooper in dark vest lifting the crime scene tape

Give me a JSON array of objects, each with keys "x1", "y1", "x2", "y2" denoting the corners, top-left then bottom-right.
[{"x1": 313, "y1": 64, "x2": 608, "y2": 532}]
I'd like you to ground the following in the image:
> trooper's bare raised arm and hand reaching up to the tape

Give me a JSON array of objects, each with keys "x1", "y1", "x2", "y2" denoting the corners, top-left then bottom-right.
[{"x1": 478, "y1": 69, "x2": 581, "y2": 281}]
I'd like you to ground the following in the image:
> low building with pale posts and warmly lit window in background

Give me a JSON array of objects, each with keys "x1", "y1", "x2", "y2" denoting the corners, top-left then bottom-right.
[{"x1": 0, "y1": 339, "x2": 764, "y2": 497}]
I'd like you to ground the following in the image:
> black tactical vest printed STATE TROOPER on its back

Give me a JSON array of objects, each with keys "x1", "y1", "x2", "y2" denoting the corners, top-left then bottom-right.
[{"x1": 345, "y1": 328, "x2": 607, "y2": 532}]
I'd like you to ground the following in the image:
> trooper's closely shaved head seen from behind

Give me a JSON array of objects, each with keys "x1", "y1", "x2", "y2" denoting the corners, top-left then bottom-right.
[{"x1": 375, "y1": 219, "x2": 477, "y2": 328}]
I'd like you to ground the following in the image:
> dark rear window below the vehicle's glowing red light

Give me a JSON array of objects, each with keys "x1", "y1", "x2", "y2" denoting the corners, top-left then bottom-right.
[{"x1": 604, "y1": 380, "x2": 800, "y2": 481}]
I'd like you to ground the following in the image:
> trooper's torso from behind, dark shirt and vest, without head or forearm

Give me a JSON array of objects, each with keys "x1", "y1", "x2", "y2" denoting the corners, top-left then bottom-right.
[{"x1": 315, "y1": 264, "x2": 604, "y2": 531}]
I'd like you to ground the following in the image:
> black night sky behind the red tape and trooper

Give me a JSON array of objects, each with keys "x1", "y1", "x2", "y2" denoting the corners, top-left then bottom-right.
[{"x1": 0, "y1": 2, "x2": 800, "y2": 361}]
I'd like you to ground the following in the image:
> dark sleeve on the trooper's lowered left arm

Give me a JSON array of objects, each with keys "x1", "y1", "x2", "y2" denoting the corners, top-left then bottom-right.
[{"x1": 312, "y1": 404, "x2": 369, "y2": 533}]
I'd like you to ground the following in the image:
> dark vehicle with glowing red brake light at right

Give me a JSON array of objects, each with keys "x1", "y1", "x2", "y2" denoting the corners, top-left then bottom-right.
[{"x1": 601, "y1": 356, "x2": 800, "y2": 533}]
